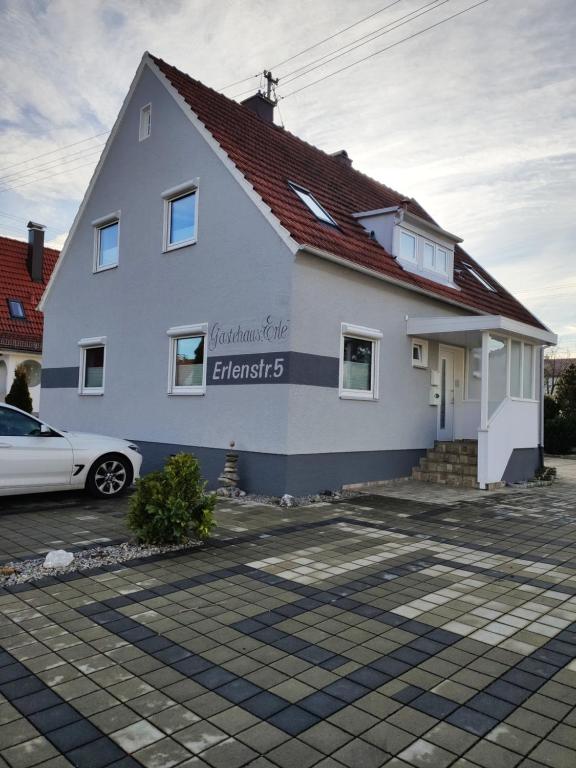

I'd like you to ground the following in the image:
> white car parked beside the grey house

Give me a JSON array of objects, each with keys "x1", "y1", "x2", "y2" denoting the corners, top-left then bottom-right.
[{"x1": 0, "y1": 403, "x2": 142, "y2": 498}]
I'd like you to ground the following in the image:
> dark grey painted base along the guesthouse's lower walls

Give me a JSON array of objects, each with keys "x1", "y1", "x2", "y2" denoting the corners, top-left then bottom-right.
[{"x1": 134, "y1": 440, "x2": 426, "y2": 496}]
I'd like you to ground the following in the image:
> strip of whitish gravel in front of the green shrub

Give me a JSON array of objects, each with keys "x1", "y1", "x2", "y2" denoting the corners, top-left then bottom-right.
[{"x1": 0, "y1": 539, "x2": 201, "y2": 587}]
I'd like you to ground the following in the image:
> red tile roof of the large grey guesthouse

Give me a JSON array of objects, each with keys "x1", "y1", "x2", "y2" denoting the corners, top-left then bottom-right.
[{"x1": 151, "y1": 56, "x2": 545, "y2": 328}]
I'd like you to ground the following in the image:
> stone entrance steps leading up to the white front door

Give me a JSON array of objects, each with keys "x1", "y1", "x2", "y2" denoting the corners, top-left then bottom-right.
[{"x1": 412, "y1": 440, "x2": 506, "y2": 490}]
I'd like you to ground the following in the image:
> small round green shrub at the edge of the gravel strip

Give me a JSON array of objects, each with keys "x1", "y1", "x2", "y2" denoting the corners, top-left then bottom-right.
[{"x1": 127, "y1": 453, "x2": 216, "y2": 544}]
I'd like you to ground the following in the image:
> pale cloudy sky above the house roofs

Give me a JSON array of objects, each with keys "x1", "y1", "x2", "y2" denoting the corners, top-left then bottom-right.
[{"x1": 0, "y1": 0, "x2": 576, "y2": 356}]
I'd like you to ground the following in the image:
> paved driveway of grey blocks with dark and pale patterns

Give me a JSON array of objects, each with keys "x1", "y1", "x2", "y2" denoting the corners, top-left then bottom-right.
[{"x1": 0, "y1": 476, "x2": 576, "y2": 768}]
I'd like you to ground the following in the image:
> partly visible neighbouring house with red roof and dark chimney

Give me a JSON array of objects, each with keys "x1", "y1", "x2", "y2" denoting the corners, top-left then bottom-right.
[{"x1": 0, "y1": 221, "x2": 60, "y2": 412}]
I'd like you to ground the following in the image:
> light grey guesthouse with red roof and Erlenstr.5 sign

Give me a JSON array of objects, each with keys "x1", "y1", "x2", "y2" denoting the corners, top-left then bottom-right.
[{"x1": 41, "y1": 54, "x2": 556, "y2": 494}]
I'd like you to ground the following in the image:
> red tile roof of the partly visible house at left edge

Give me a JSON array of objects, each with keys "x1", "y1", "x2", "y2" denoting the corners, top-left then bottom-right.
[{"x1": 0, "y1": 236, "x2": 60, "y2": 352}]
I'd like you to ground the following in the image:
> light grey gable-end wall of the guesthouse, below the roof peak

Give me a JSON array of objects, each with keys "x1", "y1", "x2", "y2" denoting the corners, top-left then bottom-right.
[{"x1": 41, "y1": 70, "x2": 292, "y2": 452}]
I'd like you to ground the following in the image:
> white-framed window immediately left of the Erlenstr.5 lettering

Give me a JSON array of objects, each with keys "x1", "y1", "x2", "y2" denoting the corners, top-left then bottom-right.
[{"x1": 166, "y1": 323, "x2": 208, "y2": 395}]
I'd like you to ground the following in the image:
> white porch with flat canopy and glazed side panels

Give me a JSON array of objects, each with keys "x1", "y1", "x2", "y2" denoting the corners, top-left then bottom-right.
[{"x1": 407, "y1": 316, "x2": 556, "y2": 488}]
